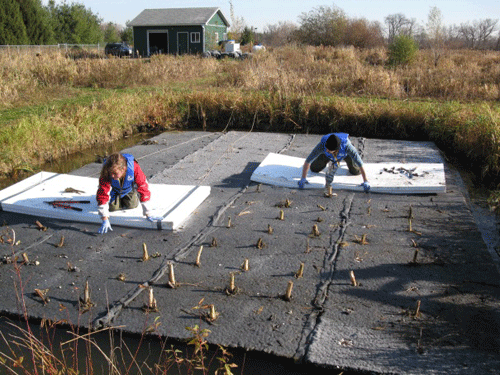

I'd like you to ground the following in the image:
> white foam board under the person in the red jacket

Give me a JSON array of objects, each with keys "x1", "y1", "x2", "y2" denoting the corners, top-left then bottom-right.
[{"x1": 0, "y1": 172, "x2": 210, "y2": 230}]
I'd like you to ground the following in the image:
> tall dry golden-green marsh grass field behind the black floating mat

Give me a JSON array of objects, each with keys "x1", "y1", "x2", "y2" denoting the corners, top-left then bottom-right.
[{"x1": 0, "y1": 46, "x2": 500, "y2": 186}]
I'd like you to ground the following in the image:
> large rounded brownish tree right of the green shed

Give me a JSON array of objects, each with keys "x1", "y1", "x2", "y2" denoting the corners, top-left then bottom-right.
[{"x1": 297, "y1": 6, "x2": 348, "y2": 46}]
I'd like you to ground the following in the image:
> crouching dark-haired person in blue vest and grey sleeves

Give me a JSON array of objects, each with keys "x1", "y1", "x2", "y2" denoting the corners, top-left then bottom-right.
[{"x1": 298, "y1": 133, "x2": 370, "y2": 193}]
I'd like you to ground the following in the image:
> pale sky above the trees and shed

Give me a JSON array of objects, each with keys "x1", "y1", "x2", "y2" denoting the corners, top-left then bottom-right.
[{"x1": 42, "y1": 0, "x2": 500, "y2": 32}]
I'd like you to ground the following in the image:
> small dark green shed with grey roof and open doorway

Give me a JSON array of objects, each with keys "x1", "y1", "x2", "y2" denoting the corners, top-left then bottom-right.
[{"x1": 127, "y1": 7, "x2": 230, "y2": 56}]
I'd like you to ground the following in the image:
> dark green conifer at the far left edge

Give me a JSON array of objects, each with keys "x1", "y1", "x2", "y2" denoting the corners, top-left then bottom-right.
[{"x1": 0, "y1": 0, "x2": 29, "y2": 45}]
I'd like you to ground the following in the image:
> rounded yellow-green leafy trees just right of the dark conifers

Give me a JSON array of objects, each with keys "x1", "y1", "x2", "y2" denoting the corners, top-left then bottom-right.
[{"x1": 48, "y1": 0, "x2": 104, "y2": 44}]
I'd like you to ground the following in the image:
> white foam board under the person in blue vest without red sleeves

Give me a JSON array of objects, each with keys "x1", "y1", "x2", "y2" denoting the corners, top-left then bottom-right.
[{"x1": 250, "y1": 153, "x2": 446, "y2": 194}]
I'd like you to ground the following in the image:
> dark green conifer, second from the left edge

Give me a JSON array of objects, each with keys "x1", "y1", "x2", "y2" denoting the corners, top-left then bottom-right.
[{"x1": 16, "y1": 0, "x2": 54, "y2": 45}]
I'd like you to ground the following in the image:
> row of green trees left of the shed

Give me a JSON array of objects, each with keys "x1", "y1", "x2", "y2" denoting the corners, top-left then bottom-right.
[{"x1": 0, "y1": 0, "x2": 132, "y2": 45}]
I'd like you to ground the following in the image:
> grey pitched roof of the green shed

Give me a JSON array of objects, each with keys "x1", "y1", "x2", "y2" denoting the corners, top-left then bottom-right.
[{"x1": 127, "y1": 7, "x2": 229, "y2": 26}]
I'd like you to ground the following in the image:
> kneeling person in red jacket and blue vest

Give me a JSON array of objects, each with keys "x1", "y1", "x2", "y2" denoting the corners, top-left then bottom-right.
[{"x1": 96, "y1": 153, "x2": 162, "y2": 234}]
